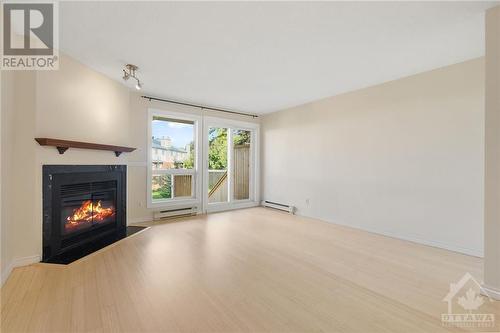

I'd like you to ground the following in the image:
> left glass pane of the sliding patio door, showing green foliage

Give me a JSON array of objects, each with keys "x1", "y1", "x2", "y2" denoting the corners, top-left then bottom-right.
[{"x1": 208, "y1": 127, "x2": 228, "y2": 203}]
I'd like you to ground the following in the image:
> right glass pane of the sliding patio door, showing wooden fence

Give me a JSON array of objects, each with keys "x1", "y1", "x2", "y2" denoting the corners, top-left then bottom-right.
[{"x1": 233, "y1": 130, "x2": 252, "y2": 200}]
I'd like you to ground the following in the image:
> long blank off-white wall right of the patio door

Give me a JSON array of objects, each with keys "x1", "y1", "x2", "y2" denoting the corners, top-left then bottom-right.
[{"x1": 262, "y1": 58, "x2": 484, "y2": 256}]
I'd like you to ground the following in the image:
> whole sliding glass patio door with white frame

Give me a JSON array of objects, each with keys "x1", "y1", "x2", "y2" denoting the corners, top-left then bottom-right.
[{"x1": 203, "y1": 117, "x2": 258, "y2": 212}]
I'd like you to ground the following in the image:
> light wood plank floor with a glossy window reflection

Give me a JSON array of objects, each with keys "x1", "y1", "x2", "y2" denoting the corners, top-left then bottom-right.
[{"x1": 1, "y1": 208, "x2": 500, "y2": 332}]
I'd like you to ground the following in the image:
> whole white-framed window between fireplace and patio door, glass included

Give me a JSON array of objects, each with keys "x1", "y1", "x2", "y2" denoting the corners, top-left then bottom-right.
[{"x1": 148, "y1": 110, "x2": 199, "y2": 207}]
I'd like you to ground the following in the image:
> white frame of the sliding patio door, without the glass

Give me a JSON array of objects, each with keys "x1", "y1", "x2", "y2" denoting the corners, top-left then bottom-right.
[{"x1": 202, "y1": 116, "x2": 260, "y2": 212}]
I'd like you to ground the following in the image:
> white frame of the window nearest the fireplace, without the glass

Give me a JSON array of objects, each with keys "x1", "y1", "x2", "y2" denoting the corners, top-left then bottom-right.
[{"x1": 147, "y1": 109, "x2": 203, "y2": 208}]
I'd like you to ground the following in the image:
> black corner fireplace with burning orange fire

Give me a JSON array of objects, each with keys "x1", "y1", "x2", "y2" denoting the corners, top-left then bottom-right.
[{"x1": 42, "y1": 165, "x2": 127, "y2": 263}]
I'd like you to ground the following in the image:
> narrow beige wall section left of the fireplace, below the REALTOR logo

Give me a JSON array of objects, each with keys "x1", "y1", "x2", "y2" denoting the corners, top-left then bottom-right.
[{"x1": 1, "y1": 71, "x2": 35, "y2": 281}]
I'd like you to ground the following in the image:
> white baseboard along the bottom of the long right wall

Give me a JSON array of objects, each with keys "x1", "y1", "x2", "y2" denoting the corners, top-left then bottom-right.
[{"x1": 296, "y1": 212, "x2": 484, "y2": 258}]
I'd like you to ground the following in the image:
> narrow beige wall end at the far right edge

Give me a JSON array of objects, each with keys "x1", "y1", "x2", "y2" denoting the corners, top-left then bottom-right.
[{"x1": 484, "y1": 6, "x2": 500, "y2": 299}]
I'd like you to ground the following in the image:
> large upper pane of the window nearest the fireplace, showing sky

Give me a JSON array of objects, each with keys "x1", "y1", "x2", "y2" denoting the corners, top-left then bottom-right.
[{"x1": 151, "y1": 117, "x2": 195, "y2": 170}]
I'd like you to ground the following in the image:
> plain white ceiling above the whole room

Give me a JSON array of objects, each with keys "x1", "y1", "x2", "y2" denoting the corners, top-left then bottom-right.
[{"x1": 59, "y1": 1, "x2": 498, "y2": 114}]
